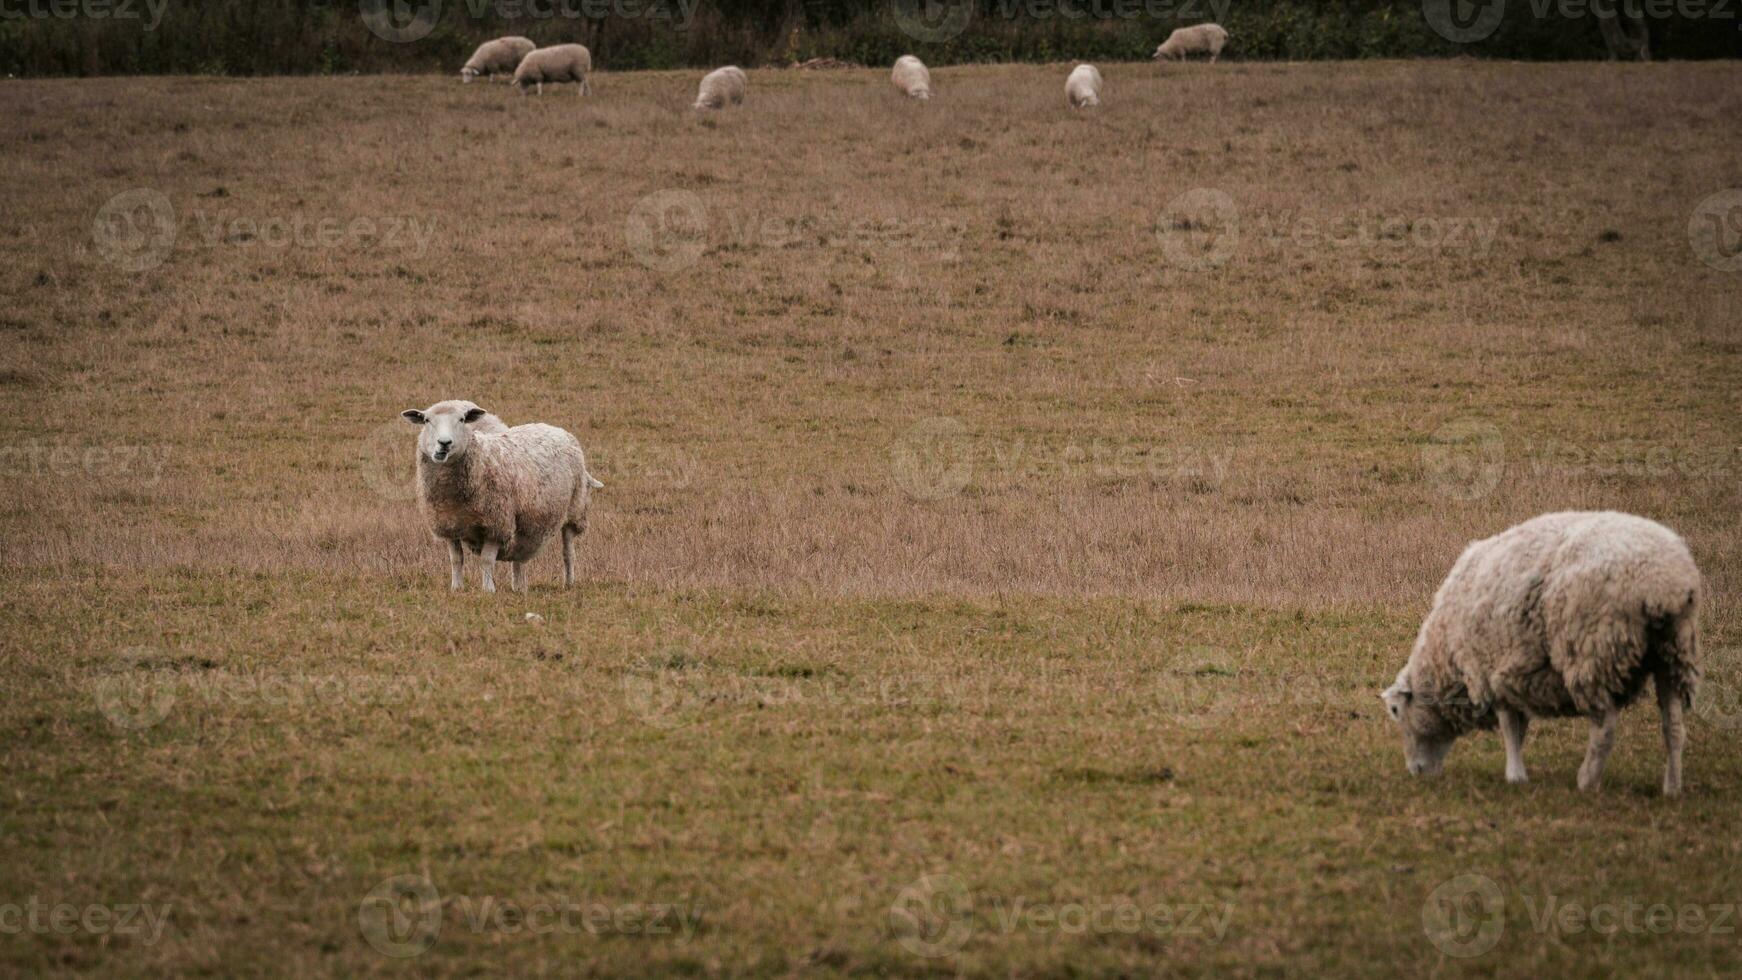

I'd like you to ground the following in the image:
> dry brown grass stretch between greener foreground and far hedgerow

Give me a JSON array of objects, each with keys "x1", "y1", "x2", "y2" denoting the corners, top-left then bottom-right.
[{"x1": 0, "y1": 63, "x2": 1742, "y2": 604}]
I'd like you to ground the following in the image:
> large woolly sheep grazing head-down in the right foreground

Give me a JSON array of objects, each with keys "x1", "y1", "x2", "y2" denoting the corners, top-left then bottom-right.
[{"x1": 1380, "y1": 512, "x2": 1700, "y2": 795}]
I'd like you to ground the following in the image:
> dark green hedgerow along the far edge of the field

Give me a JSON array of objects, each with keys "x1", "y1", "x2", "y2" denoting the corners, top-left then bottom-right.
[{"x1": 0, "y1": 0, "x2": 1742, "y2": 77}]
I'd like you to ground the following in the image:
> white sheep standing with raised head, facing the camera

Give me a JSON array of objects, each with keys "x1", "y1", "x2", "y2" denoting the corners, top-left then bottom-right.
[{"x1": 401, "y1": 400, "x2": 604, "y2": 592}]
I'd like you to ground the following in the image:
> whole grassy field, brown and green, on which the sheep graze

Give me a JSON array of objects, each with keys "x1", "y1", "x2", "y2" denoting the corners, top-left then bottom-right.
[{"x1": 0, "y1": 63, "x2": 1742, "y2": 977}]
